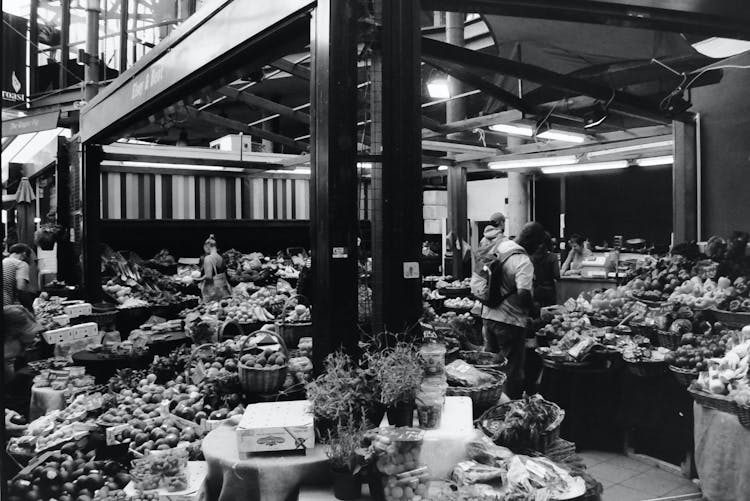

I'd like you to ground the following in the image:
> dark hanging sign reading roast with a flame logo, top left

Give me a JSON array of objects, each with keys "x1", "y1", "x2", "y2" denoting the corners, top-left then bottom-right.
[{"x1": 0, "y1": 12, "x2": 28, "y2": 107}]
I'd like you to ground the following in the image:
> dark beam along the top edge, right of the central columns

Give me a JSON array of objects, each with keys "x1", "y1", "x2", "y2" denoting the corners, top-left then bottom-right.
[{"x1": 422, "y1": 0, "x2": 750, "y2": 40}]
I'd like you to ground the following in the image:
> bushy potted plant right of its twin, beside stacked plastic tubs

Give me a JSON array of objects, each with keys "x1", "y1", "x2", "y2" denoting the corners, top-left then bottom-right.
[{"x1": 366, "y1": 342, "x2": 423, "y2": 426}]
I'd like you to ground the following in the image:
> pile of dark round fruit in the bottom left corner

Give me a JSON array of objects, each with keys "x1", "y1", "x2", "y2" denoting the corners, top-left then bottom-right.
[{"x1": 8, "y1": 447, "x2": 130, "y2": 501}]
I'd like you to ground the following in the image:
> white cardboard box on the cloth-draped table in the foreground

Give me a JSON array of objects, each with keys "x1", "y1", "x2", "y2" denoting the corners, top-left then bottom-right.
[{"x1": 237, "y1": 400, "x2": 315, "y2": 457}]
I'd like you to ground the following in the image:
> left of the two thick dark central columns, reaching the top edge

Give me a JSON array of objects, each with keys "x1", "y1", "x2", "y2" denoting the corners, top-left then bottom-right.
[{"x1": 310, "y1": 0, "x2": 359, "y2": 372}]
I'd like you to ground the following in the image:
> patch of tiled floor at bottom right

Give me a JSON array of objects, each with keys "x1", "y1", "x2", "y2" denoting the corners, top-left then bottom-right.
[{"x1": 580, "y1": 451, "x2": 701, "y2": 501}]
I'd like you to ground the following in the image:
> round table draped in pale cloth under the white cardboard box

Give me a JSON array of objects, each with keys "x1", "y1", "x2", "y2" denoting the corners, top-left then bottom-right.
[{"x1": 202, "y1": 426, "x2": 333, "y2": 501}]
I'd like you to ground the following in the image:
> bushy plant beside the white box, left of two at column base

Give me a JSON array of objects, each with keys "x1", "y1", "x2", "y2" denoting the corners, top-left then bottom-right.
[{"x1": 306, "y1": 351, "x2": 383, "y2": 438}]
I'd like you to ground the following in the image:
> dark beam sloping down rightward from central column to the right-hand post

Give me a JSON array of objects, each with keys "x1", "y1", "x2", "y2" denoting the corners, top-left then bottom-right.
[{"x1": 422, "y1": 39, "x2": 692, "y2": 124}]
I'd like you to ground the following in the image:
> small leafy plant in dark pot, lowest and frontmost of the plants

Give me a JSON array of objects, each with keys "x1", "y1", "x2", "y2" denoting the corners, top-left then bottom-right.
[{"x1": 325, "y1": 425, "x2": 364, "y2": 500}]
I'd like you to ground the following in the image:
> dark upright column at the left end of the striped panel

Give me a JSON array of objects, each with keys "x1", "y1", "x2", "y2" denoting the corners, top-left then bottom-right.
[{"x1": 81, "y1": 143, "x2": 104, "y2": 302}]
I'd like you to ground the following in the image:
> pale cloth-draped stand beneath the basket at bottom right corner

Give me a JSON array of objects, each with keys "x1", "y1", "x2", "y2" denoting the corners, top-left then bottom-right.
[{"x1": 693, "y1": 404, "x2": 750, "y2": 501}]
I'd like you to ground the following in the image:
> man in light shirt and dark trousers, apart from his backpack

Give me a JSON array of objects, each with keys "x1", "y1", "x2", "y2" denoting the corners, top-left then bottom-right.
[{"x1": 482, "y1": 222, "x2": 545, "y2": 399}]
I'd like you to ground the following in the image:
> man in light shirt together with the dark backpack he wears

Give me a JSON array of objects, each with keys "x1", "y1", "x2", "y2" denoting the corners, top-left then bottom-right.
[{"x1": 471, "y1": 222, "x2": 545, "y2": 399}]
